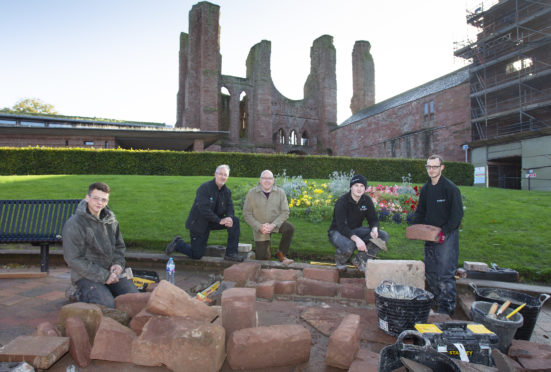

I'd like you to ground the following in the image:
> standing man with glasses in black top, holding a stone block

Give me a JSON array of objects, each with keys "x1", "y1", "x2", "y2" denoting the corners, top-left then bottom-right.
[{"x1": 412, "y1": 155, "x2": 463, "y2": 315}]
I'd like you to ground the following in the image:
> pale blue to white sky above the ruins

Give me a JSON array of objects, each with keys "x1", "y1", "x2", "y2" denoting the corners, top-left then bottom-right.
[{"x1": 0, "y1": 0, "x2": 475, "y2": 126}]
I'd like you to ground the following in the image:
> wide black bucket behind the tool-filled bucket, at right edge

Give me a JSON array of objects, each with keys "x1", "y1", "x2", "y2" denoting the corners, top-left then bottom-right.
[{"x1": 470, "y1": 283, "x2": 550, "y2": 341}]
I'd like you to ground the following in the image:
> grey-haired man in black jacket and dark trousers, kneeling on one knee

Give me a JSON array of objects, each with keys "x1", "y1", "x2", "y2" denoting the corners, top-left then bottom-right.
[{"x1": 165, "y1": 164, "x2": 243, "y2": 262}]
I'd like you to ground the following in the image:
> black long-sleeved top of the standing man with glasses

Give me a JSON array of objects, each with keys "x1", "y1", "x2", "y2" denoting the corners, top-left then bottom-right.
[{"x1": 413, "y1": 176, "x2": 463, "y2": 235}]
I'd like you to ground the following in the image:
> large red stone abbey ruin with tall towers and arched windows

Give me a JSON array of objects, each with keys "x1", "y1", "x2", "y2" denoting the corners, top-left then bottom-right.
[{"x1": 176, "y1": 2, "x2": 337, "y2": 154}]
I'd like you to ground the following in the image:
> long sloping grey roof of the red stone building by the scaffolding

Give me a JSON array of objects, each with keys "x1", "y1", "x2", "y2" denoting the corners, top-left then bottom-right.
[{"x1": 333, "y1": 67, "x2": 469, "y2": 130}]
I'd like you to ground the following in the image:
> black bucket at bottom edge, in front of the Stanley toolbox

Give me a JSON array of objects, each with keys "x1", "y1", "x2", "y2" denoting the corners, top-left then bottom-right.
[{"x1": 379, "y1": 330, "x2": 461, "y2": 372}]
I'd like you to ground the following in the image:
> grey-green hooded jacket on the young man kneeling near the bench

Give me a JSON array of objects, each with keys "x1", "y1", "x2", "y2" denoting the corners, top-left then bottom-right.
[{"x1": 62, "y1": 200, "x2": 126, "y2": 284}]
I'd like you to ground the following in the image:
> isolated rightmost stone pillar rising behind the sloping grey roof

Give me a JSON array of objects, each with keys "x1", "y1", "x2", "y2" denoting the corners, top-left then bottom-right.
[{"x1": 350, "y1": 40, "x2": 375, "y2": 114}]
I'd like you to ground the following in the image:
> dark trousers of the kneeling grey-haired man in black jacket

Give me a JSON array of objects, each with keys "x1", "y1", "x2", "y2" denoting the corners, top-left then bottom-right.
[{"x1": 174, "y1": 216, "x2": 241, "y2": 260}]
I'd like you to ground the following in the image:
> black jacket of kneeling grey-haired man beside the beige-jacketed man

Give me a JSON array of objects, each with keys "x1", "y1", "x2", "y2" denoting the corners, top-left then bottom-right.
[{"x1": 186, "y1": 179, "x2": 234, "y2": 234}]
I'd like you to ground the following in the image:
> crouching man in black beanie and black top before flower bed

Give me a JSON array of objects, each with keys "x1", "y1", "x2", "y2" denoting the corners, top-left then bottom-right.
[{"x1": 329, "y1": 175, "x2": 388, "y2": 272}]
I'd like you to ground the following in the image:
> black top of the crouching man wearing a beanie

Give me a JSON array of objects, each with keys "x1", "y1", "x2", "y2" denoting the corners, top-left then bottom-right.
[{"x1": 329, "y1": 192, "x2": 379, "y2": 238}]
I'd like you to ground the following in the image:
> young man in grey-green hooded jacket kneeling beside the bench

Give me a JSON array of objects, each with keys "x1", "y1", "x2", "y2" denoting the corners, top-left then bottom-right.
[{"x1": 62, "y1": 182, "x2": 138, "y2": 308}]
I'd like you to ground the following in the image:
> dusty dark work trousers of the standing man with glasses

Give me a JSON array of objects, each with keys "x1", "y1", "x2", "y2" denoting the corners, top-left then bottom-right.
[{"x1": 425, "y1": 230, "x2": 459, "y2": 314}]
